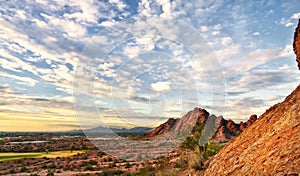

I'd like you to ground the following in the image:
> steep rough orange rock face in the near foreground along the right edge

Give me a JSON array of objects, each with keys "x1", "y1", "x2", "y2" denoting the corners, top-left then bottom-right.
[{"x1": 205, "y1": 20, "x2": 300, "y2": 176}]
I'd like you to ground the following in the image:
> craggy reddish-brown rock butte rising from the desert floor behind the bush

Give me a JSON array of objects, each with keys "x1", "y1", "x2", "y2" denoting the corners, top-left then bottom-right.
[{"x1": 143, "y1": 108, "x2": 257, "y2": 142}]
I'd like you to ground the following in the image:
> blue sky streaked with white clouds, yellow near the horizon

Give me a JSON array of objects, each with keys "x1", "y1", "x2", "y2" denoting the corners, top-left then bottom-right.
[{"x1": 0, "y1": 0, "x2": 300, "y2": 131}]
